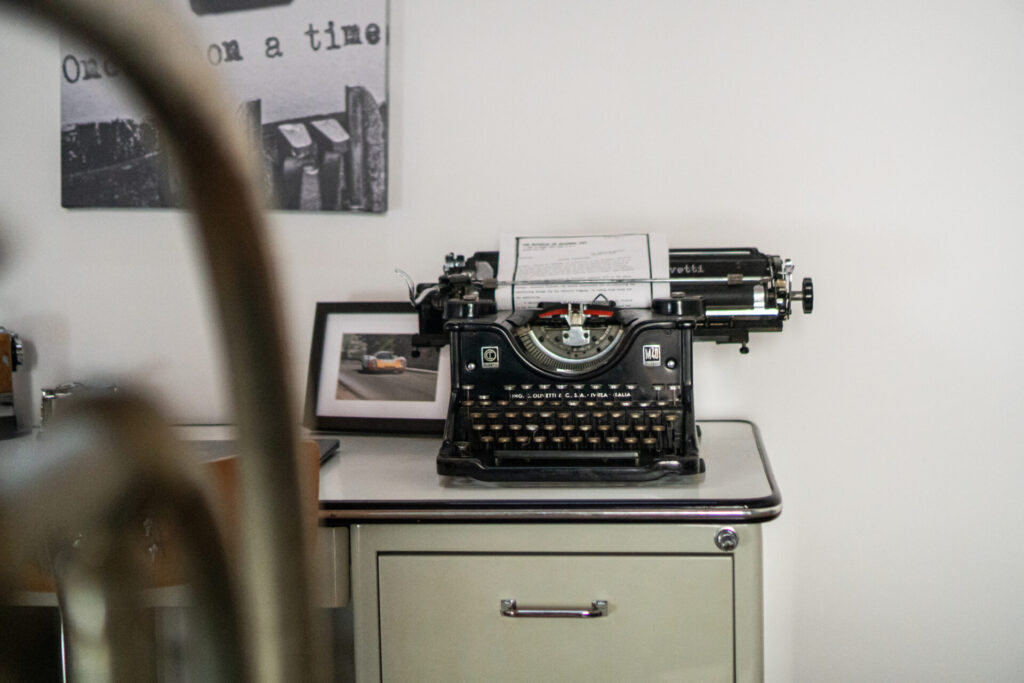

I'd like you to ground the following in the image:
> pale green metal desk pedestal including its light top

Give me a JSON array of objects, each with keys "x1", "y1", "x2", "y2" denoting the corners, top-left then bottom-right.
[{"x1": 321, "y1": 422, "x2": 780, "y2": 682}]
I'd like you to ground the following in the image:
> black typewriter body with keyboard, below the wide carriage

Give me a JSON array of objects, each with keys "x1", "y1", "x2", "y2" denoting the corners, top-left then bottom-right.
[{"x1": 437, "y1": 304, "x2": 703, "y2": 482}]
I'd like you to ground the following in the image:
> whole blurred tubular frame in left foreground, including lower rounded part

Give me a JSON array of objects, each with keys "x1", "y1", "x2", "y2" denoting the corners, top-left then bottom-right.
[{"x1": 0, "y1": 0, "x2": 318, "y2": 682}]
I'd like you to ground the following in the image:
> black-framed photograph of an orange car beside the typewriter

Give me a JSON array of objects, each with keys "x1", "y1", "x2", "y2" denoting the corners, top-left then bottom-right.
[{"x1": 305, "y1": 302, "x2": 452, "y2": 434}]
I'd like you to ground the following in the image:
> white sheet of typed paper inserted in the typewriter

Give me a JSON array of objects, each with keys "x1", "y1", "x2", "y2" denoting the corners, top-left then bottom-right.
[{"x1": 495, "y1": 233, "x2": 669, "y2": 310}]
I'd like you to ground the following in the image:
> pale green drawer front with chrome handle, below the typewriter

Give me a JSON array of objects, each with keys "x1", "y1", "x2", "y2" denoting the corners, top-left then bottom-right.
[{"x1": 377, "y1": 553, "x2": 734, "y2": 682}]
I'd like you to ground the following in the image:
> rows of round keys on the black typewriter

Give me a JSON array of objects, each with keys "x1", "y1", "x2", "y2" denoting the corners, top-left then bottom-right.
[{"x1": 456, "y1": 398, "x2": 683, "y2": 465}]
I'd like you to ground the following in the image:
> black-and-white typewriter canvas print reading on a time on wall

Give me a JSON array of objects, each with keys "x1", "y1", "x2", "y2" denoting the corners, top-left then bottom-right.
[{"x1": 60, "y1": 0, "x2": 388, "y2": 213}]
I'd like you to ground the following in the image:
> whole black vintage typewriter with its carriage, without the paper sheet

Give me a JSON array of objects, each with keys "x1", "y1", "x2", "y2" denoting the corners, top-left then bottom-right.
[{"x1": 410, "y1": 249, "x2": 814, "y2": 482}]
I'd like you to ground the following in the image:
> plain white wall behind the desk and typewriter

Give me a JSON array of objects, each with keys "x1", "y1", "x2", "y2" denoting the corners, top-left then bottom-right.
[{"x1": 0, "y1": 0, "x2": 1024, "y2": 681}]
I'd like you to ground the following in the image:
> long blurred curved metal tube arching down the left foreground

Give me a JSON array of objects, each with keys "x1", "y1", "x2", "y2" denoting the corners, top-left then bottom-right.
[{"x1": 0, "y1": 0, "x2": 315, "y2": 683}]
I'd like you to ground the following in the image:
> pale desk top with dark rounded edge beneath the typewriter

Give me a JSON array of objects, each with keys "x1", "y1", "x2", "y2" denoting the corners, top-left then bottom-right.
[{"x1": 319, "y1": 422, "x2": 781, "y2": 521}]
